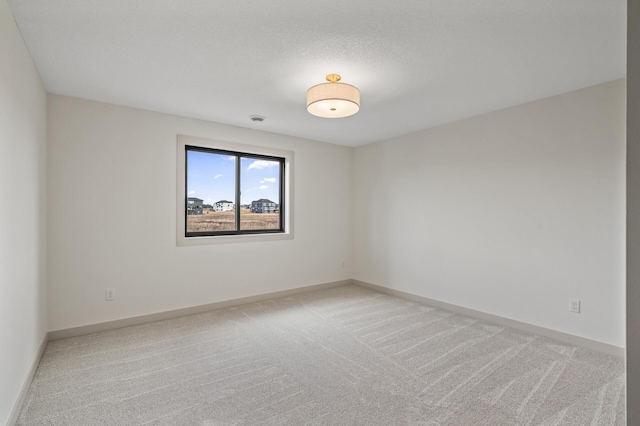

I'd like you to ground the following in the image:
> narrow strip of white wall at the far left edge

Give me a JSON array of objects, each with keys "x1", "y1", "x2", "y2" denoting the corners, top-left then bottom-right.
[{"x1": 0, "y1": 0, "x2": 47, "y2": 424}]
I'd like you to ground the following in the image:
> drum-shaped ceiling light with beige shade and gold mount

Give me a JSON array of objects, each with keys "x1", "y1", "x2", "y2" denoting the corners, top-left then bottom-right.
[{"x1": 307, "y1": 74, "x2": 360, "y2": 118}]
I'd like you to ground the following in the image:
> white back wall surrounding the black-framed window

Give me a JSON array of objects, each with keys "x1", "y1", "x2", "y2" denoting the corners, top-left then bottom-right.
[{"x1": 48, "y1": 95, "x2": 352, "y2": 330}]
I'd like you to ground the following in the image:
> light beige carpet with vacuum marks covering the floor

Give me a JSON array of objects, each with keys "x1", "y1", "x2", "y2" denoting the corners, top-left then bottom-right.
[{"x1": 18, "y1": 286, "x2": 625, "y2": 426}]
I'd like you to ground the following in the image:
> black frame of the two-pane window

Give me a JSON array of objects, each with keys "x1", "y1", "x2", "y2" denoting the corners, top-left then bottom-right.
[{"x1": 183, "y1": 144, "x2": 286, "y2": 238}]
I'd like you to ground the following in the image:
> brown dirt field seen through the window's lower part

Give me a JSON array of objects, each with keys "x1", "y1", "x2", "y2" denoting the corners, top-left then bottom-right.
[{"x1": 187, "y1": 209, "x2": 279, "y2": 232}]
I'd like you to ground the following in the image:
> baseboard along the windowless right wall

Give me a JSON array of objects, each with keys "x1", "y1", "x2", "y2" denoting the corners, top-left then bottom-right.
[{"x1": 352, "y1": 280, "x2": 625, "y2": 358}]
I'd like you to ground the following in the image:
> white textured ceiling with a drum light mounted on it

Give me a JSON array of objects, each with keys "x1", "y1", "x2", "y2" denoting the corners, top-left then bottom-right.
[{"x1": 8, "y1": 0, "x2": 626, "y2": 146}]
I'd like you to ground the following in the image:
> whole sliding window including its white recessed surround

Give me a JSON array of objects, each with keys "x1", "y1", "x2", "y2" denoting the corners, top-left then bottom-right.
[{"x1": 177, "y1": 136, "x2": 293, "y2": 245}]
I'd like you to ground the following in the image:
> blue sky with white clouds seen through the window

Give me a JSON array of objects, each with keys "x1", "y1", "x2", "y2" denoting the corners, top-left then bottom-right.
[{"x1": 187, "y1": 151, "x2": 280, "y2": 204}]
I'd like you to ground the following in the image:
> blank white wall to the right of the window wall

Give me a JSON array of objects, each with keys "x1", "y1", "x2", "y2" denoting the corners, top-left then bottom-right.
[{"x1": 353, "y1": 80, "x2": 625, "y2": 347}]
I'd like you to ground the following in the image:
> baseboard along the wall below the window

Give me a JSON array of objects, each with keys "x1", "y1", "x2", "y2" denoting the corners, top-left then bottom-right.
[{"x1": 49, "y1": 279, "x2": 351, "y2": 340}]
